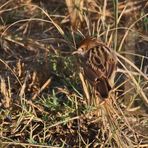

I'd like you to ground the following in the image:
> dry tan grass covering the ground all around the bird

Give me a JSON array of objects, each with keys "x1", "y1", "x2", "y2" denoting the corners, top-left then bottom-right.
[{"x1": 0, "y1": 0, "x2": 148, "y2": 148}]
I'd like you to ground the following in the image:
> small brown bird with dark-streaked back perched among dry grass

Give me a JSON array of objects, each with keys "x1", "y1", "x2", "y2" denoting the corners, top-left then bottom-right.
[{"x1": 73, "y1": 38, "x2": 117, "y2": 100}]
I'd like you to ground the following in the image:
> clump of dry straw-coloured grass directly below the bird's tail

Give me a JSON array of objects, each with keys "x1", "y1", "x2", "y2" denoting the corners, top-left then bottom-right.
[{"x1": 97, "y1": 100, "x2": 133, "y2": 147}]
